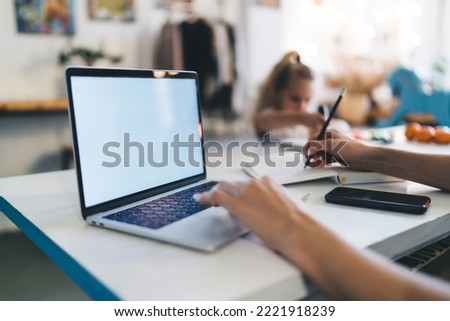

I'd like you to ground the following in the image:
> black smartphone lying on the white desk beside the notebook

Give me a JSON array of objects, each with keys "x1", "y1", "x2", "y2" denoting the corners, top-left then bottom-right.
[{"x1": 325, "y1": 187, "x2": 431, "y2": 214}]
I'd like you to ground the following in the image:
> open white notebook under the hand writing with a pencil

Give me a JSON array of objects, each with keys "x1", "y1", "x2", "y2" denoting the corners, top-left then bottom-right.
[{"x1": 241, "y1": 151, "x2": 402, "y2": 185}]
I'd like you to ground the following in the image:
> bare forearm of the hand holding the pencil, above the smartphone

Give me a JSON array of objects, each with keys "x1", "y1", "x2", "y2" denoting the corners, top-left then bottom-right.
[{"x1": 361, "y1": 148, "x2": 450, "y2": 191}]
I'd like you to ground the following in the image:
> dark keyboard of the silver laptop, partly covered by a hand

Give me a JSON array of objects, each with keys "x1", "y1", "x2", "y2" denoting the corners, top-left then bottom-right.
[{"x1": 104, "y1": 181, "x2": 217, "y2": 229}]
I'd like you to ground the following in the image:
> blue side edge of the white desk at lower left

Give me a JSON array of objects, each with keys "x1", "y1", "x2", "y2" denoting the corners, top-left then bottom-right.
[{"x1": 0, "y1": 196, "x2": 120, "y2": 301}]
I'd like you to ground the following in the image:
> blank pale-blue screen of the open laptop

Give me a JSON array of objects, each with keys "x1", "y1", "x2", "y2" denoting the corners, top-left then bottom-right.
[{"x1": 71, "y1": 76, "x2": 204, "y2": 207}]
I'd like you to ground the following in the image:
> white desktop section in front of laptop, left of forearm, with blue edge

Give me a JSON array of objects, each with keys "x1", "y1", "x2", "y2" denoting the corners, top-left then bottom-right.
[{"x1": 0, "y1": 170, "x2": 306, "y2": 301}]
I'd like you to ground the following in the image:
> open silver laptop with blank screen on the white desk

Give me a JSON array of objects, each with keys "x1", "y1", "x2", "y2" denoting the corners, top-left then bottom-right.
[{"x1": 66, "y1": 67, "x2": 247, "y2": 251}]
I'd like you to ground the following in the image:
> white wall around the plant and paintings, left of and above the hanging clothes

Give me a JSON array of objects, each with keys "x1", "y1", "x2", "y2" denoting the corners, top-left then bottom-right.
[{"x1": 0, "y1": 0, "x2": 242, "y2": 100}]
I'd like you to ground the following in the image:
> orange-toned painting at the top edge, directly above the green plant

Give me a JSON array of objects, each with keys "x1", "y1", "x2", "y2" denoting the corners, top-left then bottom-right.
[{"x1": 87, "y1": 0, "x2": 134, "y2": 22}]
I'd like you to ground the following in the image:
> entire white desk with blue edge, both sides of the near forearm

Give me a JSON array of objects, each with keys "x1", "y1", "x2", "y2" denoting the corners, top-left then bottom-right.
[{"x1": 0, "y1": 138, "x2": 450, "y2": 300}]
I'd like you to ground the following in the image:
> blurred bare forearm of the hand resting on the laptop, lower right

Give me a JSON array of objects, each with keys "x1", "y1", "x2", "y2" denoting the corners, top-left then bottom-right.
[{"x1": 282, "y1": 214, "x2": 450, "y2": 300}]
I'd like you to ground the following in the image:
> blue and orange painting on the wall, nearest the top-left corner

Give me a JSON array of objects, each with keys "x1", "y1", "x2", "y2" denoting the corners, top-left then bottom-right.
[{"x1": 14, "y1": 0, "x2": 74, "y2": 35}]
